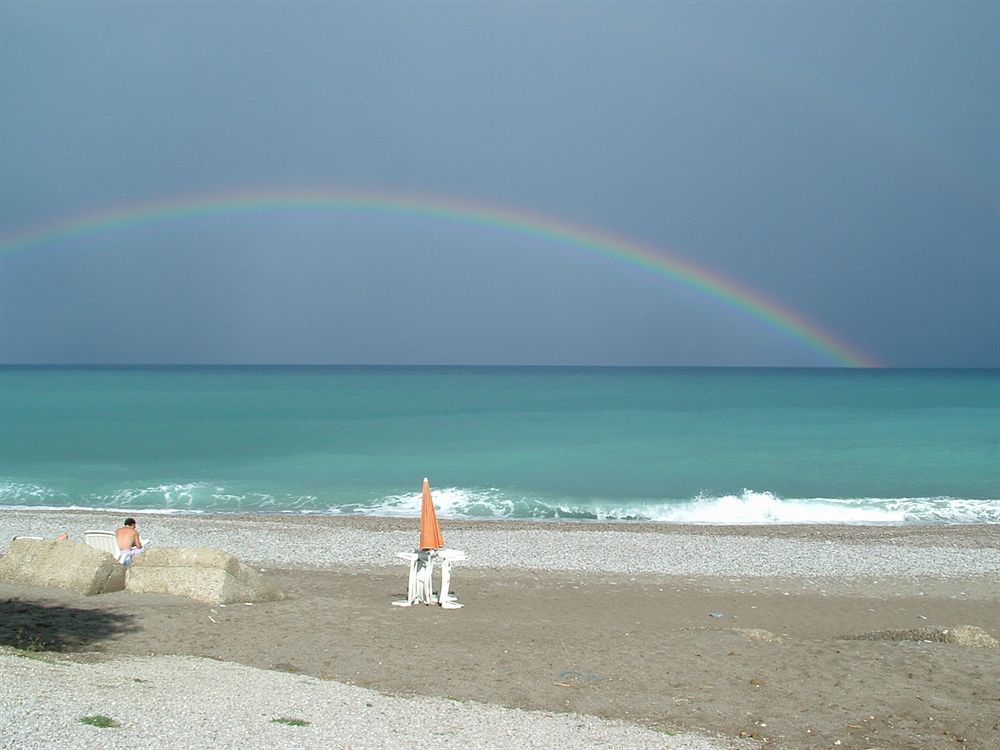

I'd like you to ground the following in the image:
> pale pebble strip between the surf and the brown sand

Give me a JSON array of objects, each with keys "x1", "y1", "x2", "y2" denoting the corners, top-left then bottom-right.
[{"x1": 0, "y1": 510, "x2": 1000, "y2": 578}]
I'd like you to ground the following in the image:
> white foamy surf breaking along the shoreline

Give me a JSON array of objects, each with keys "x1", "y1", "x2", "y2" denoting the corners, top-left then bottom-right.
[{"x1": 0, "y1": 482, "x2": 1000, "y2": 526}]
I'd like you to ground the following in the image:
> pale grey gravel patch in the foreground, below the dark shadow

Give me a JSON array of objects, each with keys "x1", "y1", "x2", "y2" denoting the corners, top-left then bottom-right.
[{"x1": 0, "y1": 651, "x2": 738, "y2": 750}]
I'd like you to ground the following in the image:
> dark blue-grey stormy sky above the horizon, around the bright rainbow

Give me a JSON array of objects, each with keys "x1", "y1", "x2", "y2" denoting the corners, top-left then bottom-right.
[{"x1": 0, "y1": 0, "x2": 1000, "y2": 366}]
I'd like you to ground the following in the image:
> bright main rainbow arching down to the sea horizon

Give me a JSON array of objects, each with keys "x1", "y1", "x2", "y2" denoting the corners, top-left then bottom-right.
[{"x1": 0, "y1": 185, "x2": 881, "y2": 367}]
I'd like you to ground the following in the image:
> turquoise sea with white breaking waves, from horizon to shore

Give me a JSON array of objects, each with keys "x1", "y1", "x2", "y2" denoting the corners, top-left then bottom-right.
[{"x1": 0, "y1": 366, "x2": 1000, "y2": 525}]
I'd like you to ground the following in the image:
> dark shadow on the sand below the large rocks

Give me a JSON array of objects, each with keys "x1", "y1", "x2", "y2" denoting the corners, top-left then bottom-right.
[{"x1": 0, "y1": 599, "x2": 138, "y2": 651}]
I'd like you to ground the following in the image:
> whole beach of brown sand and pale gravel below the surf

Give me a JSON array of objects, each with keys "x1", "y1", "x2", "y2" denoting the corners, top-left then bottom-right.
[{"x1": 0, "y1": 510, "x2": 1000, "y2": 748}]
